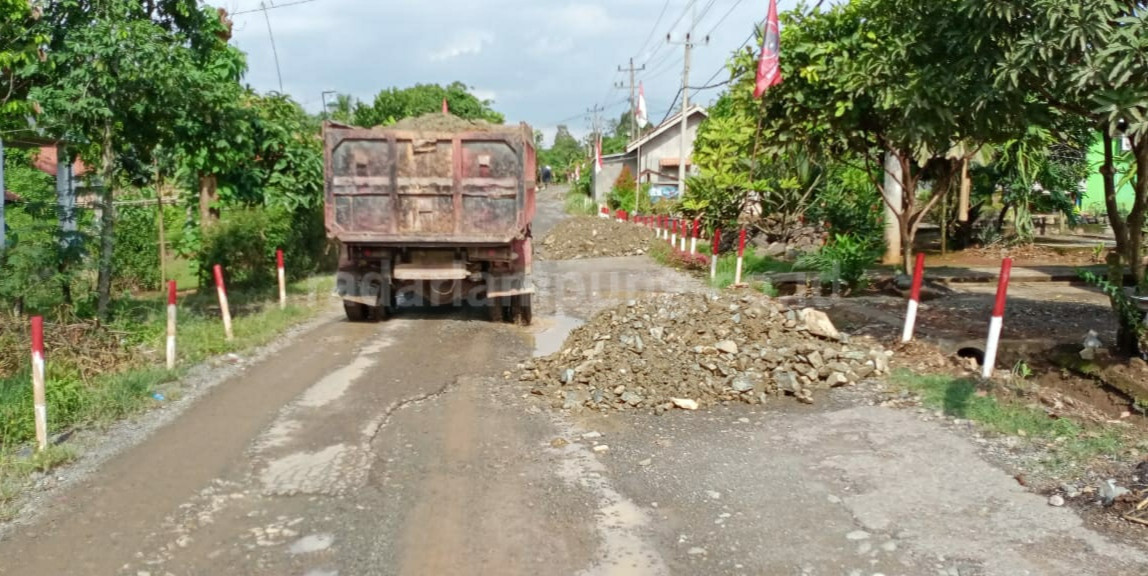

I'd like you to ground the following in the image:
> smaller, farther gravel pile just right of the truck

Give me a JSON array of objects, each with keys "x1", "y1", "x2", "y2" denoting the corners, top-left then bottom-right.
[{"x1": 536, "y1": 216, "x2": 653, "y2": 260}]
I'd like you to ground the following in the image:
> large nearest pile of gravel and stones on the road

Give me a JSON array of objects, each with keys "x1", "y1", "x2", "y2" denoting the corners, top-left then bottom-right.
[{"x1": 519, "y1": 294, "x2": 891, "y2": 414}]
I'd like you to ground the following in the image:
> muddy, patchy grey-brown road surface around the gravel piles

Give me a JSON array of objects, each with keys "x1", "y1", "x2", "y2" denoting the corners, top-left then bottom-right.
[{"x1": 0, "y1": 188, "x2": 1148, "y2": 576}]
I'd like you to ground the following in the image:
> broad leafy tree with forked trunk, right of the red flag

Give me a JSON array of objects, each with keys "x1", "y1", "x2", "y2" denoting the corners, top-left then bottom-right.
[{"x1": 730, "y1": 0, "x2": 1031, "y2": 270}]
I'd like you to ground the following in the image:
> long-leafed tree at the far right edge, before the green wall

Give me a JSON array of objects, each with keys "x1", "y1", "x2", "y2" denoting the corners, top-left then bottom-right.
[{"x1": 964, "y1": 0, "x2": 1148, "y2": 355}]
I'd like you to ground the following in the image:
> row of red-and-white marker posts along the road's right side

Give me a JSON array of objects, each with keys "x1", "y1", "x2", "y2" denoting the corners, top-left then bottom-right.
[{"x1": 602, "y1": 207, "x2": 1013, "y2": 379}]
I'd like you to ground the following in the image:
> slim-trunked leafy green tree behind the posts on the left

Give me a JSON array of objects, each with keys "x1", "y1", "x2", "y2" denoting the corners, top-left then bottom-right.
[{"x1": 30, "y1": 0, "x2": 208, "y2": 319}]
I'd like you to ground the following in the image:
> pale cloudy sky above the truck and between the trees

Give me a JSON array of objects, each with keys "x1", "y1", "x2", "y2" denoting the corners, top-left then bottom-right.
[{"x1": 223, "y1": 0, "x2": 796, "y2": 145}]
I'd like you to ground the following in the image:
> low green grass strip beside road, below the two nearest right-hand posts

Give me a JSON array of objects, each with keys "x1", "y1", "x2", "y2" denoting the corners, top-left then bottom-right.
[{"x1": 892, "y1": 372, "x2": 1127, "y2": 470}]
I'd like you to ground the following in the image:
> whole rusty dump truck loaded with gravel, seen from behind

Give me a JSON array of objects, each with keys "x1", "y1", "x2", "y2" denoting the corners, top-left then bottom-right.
[{"x1": 323, "y1": 114, "x2": 537, "y2": 324}]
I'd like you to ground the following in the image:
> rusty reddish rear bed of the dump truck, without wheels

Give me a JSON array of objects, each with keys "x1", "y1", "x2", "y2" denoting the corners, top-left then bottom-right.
[{"x1": 324, "y1": 123, "x2": 536, "y2": 247}]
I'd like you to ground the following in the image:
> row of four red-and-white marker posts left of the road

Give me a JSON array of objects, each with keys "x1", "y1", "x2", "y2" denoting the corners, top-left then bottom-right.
[{"x1": 31, "y1": 250, "x2": 287, "y2": 450}]
